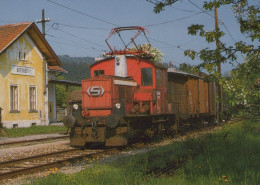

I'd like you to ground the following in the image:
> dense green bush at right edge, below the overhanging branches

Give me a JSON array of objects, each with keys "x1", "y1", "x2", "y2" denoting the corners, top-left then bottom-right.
[{"x1": 221, "y1": 55, "x2": 260, "y2": 117}]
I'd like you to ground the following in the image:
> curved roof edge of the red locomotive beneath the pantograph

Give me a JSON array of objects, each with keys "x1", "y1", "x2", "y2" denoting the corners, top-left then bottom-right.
[{"x1": 90, "y1": 55, "x2": 167, "y2": 69}]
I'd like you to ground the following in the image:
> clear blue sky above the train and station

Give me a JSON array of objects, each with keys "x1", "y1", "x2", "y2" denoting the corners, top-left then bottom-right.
[{"x1": 0, "y1": 0, "x2": 254, "y2": 73}]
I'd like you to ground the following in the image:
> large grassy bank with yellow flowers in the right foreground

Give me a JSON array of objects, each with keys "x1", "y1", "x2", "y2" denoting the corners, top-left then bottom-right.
[{"x1": 29, "y1": 121, "x2": 260, "y2": 185}]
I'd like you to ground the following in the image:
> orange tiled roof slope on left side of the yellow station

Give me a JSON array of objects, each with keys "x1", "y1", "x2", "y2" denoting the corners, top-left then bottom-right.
[{"x1": 0, "y1": 22, "x2": 32, "y2": 53}]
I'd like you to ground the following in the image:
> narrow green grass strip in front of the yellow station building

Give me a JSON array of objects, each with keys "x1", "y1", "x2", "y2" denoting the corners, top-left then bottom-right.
[{"x1": 0, "y1": 126, "x2": 67, "y2": 137}]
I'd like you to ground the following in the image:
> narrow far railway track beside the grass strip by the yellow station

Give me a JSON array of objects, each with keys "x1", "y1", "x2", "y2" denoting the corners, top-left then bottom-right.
[{"x1": 0, "y1": 136, "x2": 69, "y2": 149}]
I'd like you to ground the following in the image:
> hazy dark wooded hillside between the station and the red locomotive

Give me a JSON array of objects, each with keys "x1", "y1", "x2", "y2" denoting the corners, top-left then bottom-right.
[{"x1": 58, "y1": 55, "x2": 95, "y2": 82}]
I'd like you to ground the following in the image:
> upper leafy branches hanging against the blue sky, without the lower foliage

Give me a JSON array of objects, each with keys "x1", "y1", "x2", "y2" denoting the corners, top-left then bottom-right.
[{"x1": 149, "y1": 0, "x2": 260, "y2": 66}]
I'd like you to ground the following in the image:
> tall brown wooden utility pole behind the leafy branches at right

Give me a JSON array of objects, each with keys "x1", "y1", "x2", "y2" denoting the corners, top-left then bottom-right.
[{"x1": 214, "y1": 6, "x2": 223, "y2": 123}]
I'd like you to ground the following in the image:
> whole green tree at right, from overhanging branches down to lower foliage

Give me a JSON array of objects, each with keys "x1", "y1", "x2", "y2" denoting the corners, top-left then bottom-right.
[{"x1": 147, "y1": 0, "x2": 260, "y2": 117}]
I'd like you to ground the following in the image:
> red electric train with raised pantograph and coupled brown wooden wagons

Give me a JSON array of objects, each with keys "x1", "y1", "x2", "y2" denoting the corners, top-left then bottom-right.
[{"x1": 64, "y1": 27, "x2": 216, "y2": 146}]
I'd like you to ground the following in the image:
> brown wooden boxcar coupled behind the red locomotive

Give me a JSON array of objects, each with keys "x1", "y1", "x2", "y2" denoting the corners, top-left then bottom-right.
[{"x1": 167, "y1": 68, "x2": 216, "y2": 119}]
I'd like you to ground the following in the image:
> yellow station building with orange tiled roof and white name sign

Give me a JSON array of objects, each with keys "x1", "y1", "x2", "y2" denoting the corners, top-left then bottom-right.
[{"x1": 0, "y1": 22, "x2": 65, "y2": 128}]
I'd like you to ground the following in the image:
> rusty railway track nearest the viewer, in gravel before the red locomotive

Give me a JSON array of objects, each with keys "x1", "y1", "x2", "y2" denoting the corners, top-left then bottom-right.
[{"x1": 0, "y1": 148, "x2": 120, "y2": 181}]
